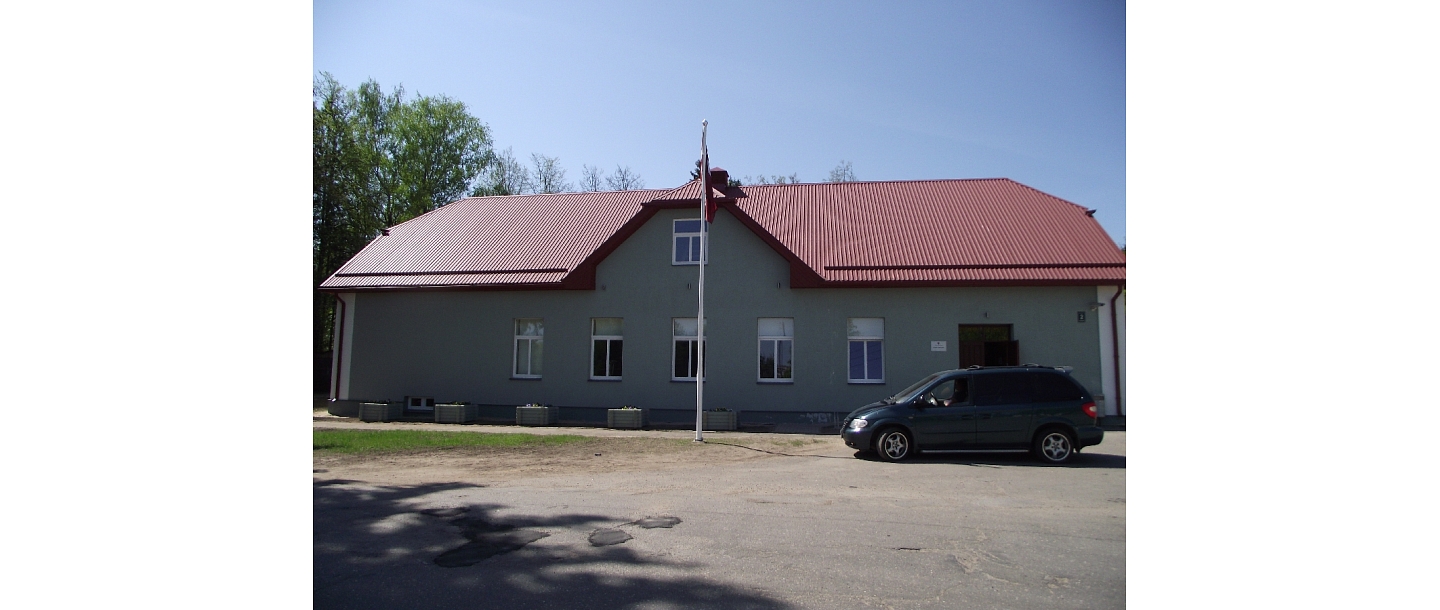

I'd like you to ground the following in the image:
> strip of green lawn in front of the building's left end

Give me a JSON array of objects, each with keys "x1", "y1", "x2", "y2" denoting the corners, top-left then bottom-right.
[{"x1": 314, "y1": 430, "x2": 586, "y2": 453}]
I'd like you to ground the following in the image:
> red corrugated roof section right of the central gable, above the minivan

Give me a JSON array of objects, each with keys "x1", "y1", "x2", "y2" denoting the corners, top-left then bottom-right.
[{"x1": 734, "y1": 178, "x2": 1125, "y2": 282}]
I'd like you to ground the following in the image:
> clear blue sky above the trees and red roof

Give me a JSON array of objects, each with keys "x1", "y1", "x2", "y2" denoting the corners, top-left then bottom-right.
[{"x1": 314, "y1": 0, "x2": 1126, "y2": 245}]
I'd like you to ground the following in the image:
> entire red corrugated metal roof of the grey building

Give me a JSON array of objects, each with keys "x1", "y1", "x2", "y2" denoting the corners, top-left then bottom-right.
[{"x1": 321, "y1": 178, "x2": 1125, "y2": 291}]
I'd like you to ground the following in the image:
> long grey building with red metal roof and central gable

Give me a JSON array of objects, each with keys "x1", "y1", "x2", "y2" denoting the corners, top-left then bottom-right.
[{"x1": 321, "y1": 170, "x2": 1125, "y2": 424}]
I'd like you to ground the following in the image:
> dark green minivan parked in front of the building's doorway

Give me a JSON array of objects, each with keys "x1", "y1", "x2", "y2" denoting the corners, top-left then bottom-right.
[{"x1": 840, "y1": 364, "x2": 1104, "y2": 463}]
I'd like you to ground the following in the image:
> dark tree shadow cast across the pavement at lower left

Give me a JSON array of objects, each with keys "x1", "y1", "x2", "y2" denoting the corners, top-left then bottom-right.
[{"x1": 312, "y1": 479, "x2": 791, "y2": 610}]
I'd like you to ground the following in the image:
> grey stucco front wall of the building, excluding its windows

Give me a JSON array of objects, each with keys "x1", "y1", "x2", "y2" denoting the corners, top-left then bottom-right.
[{"x1": 350, "y1": 210, "x2": 1100, "y2": 411}]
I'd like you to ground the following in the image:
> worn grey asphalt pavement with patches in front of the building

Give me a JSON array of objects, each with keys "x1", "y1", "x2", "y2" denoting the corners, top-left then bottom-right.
[{"x1": 314, "y1": 422, "x2": 1125, "y2": 609}]
